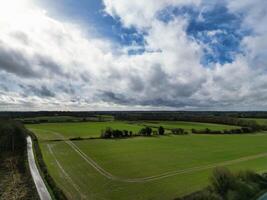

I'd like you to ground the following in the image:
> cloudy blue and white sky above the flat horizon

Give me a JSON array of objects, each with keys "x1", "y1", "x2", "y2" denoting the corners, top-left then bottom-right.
[{"x1": 0, "y1": 0, "x2": 267, "y2": 111}]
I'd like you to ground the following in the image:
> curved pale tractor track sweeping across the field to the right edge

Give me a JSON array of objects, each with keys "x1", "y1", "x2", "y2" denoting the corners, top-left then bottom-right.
[{"x1": 32, "y1": 129, "x2": 267, "y2": 183}]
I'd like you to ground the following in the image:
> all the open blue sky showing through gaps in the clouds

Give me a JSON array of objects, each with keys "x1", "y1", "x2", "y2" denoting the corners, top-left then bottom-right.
[{"x1": 39, "y1": 0, "x2": 251, "y2": 66}]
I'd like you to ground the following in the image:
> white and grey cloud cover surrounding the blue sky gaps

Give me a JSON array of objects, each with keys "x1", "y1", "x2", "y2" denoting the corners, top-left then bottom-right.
[{"x1": 0, "y1": 0, "x2": 267, "y2": 110}]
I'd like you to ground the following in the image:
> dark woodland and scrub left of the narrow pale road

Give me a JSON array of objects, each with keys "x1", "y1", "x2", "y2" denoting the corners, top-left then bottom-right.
[{"x1": 0, "y1": 120, "x2": 39, "y2": 200}]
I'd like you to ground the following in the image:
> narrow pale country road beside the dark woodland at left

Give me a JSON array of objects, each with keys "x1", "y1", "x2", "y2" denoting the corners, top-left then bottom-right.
[{"x1": 27, "y1": 136, "x2": 52, "y2": 200}]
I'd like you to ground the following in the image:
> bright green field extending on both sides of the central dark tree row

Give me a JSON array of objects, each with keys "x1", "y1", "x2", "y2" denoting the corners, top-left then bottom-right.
[{"x1": 27, "y1": 121, "x2": 267, "y2": 199}]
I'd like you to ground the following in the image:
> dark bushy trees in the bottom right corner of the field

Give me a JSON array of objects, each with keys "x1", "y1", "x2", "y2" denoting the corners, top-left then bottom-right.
[{"x1": 176, "y1": 168, "x2": 267, "y2": 200}]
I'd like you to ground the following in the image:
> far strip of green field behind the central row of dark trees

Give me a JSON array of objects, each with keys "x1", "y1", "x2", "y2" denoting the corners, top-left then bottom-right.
[{"x1": 27, "y1": 121, "x2": 241, "y2": 140}]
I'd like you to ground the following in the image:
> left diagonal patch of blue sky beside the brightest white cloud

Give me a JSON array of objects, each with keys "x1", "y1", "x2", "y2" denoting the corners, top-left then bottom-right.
[{"x1": 36, "y1": 0, "x2": 144, "y2": 45}]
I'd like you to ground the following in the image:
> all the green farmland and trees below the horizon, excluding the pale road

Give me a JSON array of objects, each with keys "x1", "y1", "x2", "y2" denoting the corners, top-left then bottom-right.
[{"x1": 0, "y1": 112, "x2": 267, "y2": 200}]
